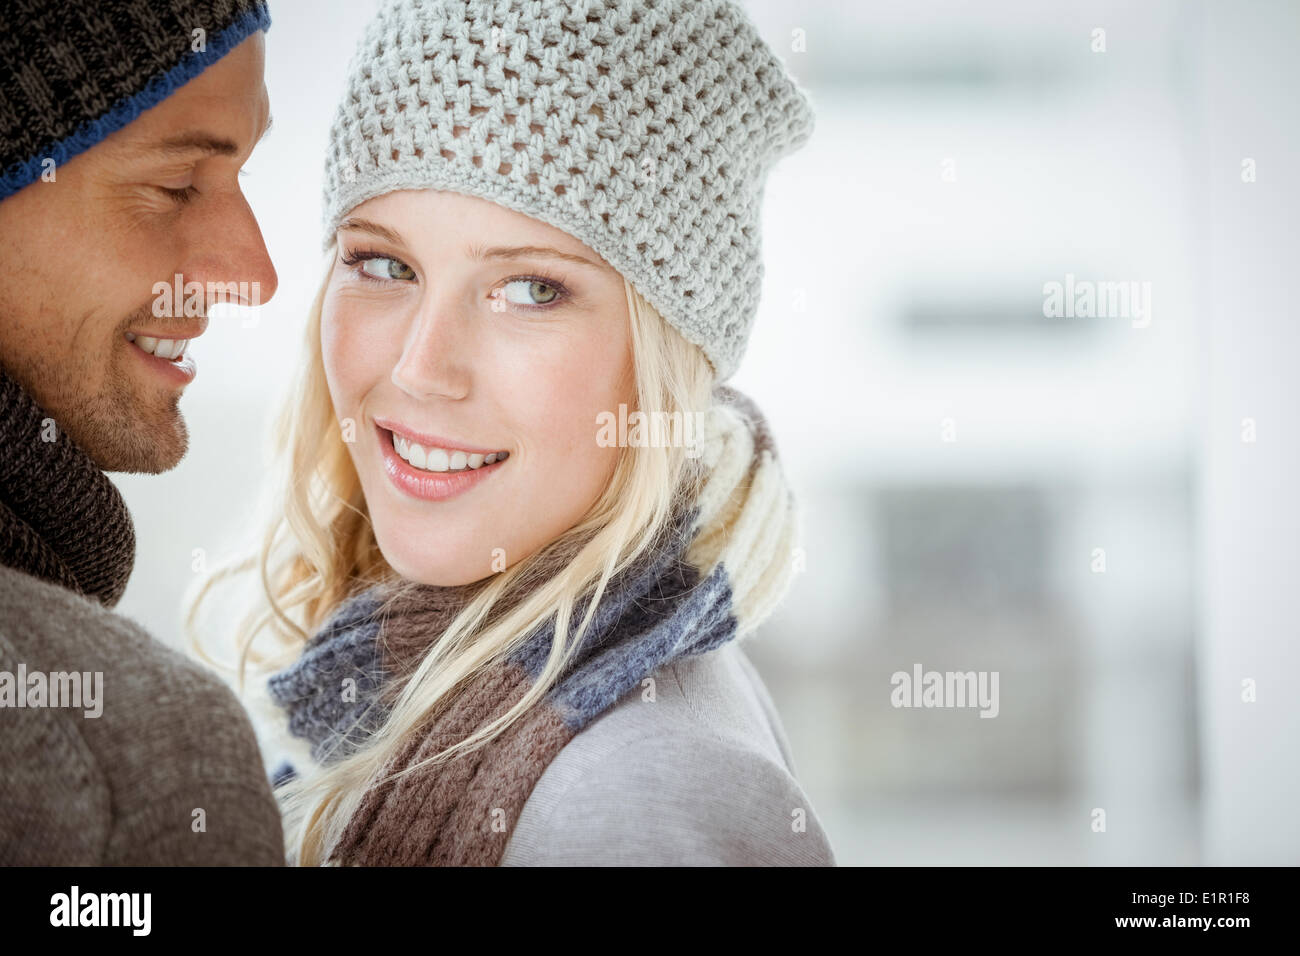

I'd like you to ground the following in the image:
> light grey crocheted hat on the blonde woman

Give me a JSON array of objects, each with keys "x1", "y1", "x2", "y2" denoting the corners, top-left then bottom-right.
[{"x1": 324, "y1": 0, "x2": 814, "y2": 381}]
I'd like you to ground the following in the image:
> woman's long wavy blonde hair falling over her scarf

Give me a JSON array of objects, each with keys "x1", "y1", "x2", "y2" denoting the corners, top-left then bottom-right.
[{"x1": 186, "y1": 250, "x2": 712, "y2": 865}]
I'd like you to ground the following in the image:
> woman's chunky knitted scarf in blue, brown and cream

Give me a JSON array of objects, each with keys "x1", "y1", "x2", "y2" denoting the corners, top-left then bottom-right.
[{"x1": 268, "y1": 386, "x2": 798, "y2": 866}]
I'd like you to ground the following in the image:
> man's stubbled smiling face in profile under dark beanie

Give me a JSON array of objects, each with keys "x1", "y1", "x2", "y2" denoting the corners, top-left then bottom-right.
[{"x1": 0, "y1": 34, "x2": 276, "y2": 473}]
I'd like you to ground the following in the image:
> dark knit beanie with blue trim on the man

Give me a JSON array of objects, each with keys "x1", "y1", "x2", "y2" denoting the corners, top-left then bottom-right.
[{"x1": 0, "y1": 0, "x2": 270, "y2": 199}]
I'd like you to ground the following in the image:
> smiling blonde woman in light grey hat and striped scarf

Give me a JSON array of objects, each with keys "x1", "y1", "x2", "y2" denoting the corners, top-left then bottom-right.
[{"x1": 191, "y1": 0, "x2": 833, "y2": 865}]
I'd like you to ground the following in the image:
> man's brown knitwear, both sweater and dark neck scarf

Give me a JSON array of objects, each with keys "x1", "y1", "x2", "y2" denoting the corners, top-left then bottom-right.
[{"x1": 0, "y1": 371, "x2": 285, "y2": 866}]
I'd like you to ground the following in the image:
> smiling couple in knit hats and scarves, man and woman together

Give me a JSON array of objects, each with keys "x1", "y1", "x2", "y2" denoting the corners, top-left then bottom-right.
[{"x1": 0, "y1": 0, "x2": 835, "y2": 865}]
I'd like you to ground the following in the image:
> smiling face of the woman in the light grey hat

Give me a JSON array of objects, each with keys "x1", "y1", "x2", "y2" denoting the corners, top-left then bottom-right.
[{"x1": 321, "y1": 190, "x2": 634, "y2": 585}]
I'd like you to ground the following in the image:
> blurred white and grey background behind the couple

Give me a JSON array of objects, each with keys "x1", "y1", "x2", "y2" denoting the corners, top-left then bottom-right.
[{"x1": 114, "y1": 0, "x2": 1300, "y2": 865}]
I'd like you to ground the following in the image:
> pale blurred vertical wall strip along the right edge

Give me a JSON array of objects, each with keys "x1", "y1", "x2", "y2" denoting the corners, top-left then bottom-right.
[{"x1": 1196, "y1": 1, "x2": 1300, "y2": 866}]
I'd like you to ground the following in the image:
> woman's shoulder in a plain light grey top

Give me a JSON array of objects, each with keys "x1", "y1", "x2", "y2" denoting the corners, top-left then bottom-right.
[{"x1": 502, "y1": 644, "x2": 835, "y2": 866}]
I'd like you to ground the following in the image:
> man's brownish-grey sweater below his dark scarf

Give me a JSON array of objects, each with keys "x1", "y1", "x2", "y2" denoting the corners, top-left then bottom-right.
[{"x1": 0, "y1": 567, "x2": 285, "y2": 866}]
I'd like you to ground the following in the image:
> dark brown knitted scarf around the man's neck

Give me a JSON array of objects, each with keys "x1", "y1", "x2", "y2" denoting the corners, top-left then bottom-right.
[{"x1": 0, "y1": 369, "x2": 135, "y2": 607}]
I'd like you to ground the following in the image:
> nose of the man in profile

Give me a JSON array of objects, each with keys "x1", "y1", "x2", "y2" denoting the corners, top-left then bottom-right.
[{"x1": 186, "y1": 185, "x2": 280, "y2": 307}]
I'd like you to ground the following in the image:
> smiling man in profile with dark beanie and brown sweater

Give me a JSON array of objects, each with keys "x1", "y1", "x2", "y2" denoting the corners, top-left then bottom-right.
[{"x1": 0, "y1": 0, "x2": 285, "y2": 865}]
